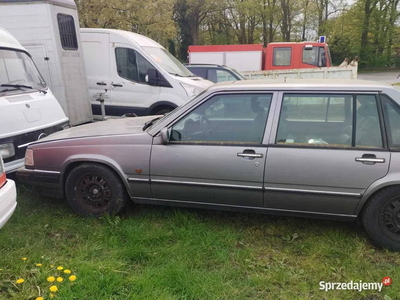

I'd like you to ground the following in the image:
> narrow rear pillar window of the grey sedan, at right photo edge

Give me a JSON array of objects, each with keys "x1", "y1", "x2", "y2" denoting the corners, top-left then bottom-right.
[{"x1": 381, "y1": 95, "x2": 400, "y2": 149}]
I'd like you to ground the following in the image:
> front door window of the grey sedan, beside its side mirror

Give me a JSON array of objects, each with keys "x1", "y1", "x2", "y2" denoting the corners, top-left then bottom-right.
[{"x1": 170, "y1": 94, "x2": 272, "y2": 145}]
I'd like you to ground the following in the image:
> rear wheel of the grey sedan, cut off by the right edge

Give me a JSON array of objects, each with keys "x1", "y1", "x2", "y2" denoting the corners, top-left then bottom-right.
[{"x1": 362, "y1": 186, "x2": 400, "y2": 251}]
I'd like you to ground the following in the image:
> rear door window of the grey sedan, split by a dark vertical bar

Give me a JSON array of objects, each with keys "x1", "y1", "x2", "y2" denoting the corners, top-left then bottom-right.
[{"x1": 276, "y1": 94, "x2": 382, "y2": 148}]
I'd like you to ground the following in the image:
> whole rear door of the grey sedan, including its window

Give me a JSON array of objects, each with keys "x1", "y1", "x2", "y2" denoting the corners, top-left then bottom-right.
[{"x1": 264, "y1": 92, "x2": 390, "y2": 215}]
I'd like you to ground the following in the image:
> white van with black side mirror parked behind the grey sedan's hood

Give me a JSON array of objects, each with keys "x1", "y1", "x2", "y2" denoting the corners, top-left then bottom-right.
[{"x1": 80, "y1": 28, "x2": 213, "y2": 116}]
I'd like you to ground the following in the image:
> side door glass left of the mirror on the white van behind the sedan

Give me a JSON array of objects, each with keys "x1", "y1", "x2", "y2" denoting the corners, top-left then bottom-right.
[{"x1": 115, "y1": 48, "x2": 139, "y2": 82}]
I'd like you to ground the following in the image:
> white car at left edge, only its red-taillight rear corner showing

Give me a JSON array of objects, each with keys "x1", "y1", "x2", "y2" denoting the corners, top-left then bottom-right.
[{"x1": 0, "y1": 155, "x2": 17, "y2": 228}]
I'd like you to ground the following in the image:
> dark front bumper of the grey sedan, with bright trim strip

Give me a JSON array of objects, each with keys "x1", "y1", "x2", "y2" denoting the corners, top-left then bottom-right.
[{"x1": 16, "y1": 168, "x2": 64, "y2": 198}]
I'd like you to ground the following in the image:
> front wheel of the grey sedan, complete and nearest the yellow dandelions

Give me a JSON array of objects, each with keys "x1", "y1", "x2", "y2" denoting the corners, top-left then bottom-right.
[{"x1": 65, "y1": 163, "x2": 128, "y2": 217}]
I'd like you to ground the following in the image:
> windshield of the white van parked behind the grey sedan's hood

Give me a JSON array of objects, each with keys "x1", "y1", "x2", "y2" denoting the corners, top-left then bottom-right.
[{"x1": 143, "y1": 47, "x2": 193, "y2": 77}]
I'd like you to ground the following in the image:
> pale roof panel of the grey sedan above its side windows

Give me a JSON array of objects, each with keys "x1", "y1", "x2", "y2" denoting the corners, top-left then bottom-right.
[{"x1": 208, "y1": 78, "x2": 395, "y2": 92}]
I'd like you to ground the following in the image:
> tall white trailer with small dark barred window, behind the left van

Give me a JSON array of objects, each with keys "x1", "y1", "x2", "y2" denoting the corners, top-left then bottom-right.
[{"x1": 0, "y1": 0, "x2": 93, "y2": 125}]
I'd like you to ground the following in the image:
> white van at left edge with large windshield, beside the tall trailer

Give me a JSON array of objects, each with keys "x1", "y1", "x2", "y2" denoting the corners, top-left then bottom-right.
[{"x1": 0, "y1": 27, "x2": 68, "y2": 172}]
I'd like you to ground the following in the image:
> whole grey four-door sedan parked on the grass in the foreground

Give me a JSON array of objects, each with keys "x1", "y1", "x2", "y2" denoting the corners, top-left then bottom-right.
[{"x1": 17, "y1": 80, "x2": 400, "y2": 251}]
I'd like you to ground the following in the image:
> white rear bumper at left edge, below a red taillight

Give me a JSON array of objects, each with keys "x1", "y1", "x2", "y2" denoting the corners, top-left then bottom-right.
[{"x1": 0, "y1": 179, "x2": 17, "y2": 228}]
